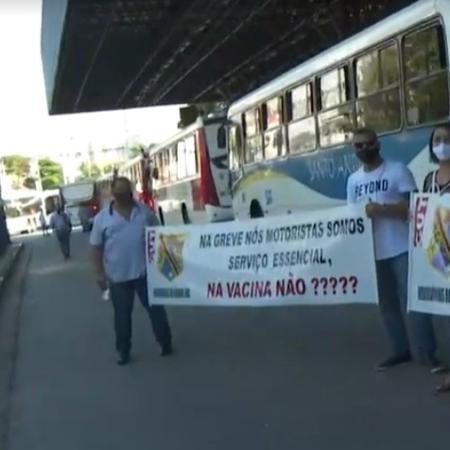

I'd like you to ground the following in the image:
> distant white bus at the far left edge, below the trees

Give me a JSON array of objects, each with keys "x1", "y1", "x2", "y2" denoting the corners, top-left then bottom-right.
[{"x1": 5, "y1": 189, "x2": 61, "y2": 235}]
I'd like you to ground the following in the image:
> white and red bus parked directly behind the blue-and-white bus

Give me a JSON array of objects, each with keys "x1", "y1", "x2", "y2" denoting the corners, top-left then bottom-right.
[{"x1": 105, "y1": 115, "x2": 233, "y2": 225}]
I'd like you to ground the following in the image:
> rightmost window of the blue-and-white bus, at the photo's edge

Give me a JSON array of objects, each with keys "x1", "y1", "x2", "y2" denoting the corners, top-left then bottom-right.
[{"x1": 403, "y1": 25, "x2": 449, "y2": 126}]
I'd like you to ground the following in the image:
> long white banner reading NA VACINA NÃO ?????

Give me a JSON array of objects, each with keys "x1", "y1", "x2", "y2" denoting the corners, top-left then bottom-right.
[{"x1": 147, "y1": 206, "x2": 378, "y2": 306}]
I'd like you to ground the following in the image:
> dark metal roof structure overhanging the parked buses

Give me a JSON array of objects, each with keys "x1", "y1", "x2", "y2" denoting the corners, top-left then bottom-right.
[{"x1": 42, "y1": 0, "x2": 413, "y2": 114}]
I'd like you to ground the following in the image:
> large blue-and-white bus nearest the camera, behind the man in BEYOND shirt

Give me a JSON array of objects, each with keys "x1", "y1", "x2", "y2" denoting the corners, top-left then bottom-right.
[{"x1": 228, "y1": 0, "x2": 450, "y2": 219}]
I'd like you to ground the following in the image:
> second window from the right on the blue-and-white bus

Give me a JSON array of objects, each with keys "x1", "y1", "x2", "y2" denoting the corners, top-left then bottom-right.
[{"x1": 355, "y1": 43, "x2": 401, "y2": 133}]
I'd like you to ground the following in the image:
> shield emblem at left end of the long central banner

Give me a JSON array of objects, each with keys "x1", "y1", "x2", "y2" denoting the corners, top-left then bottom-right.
[{"x1": 157, "y1": 233, "x2": 188, "y2": 281}]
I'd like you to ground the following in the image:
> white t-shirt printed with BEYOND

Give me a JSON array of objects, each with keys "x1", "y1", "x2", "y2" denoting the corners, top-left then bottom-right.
[{"x1": 347, "y1": 161, "x2": 416, "y2": 260}]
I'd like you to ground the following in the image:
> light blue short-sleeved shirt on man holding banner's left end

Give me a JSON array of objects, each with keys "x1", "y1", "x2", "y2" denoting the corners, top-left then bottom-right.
[{"x1": 90, "y1": 203, "x2": 159, "y2": 283}]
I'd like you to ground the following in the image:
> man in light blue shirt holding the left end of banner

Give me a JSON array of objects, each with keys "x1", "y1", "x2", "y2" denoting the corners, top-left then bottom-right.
[{"x1": 90, "y1": 177, "x2": 172, "y2": 365}]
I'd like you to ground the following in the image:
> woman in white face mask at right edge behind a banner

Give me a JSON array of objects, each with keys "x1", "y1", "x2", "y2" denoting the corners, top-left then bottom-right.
[{"x1": 423, "y1": 123, "x2": 450, "y2": 392}]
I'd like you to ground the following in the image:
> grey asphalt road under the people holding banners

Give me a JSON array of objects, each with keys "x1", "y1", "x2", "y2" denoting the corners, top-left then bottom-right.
[{"x1": 2, "y1": 233, "x2": 450, "y2": 450}]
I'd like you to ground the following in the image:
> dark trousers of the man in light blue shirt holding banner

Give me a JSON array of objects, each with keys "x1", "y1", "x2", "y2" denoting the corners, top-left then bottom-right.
[{"x1": 110, "y1": 278, "x2": 172, "y2": 354}]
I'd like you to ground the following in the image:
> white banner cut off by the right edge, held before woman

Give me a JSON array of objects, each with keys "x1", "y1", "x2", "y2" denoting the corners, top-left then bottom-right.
[{"x1": 408, "y1": 194, "x2": 450, "y2": 316}]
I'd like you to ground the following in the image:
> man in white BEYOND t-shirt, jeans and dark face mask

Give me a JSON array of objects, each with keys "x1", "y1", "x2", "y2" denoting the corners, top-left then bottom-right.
[{"x1": 347, "y1": 129, "x2": 440, "y2": 371}]
